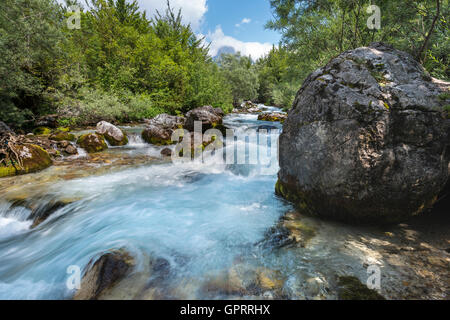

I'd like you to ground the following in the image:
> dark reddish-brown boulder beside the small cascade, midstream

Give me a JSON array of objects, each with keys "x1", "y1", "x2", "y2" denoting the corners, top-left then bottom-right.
[{"x1": 185, "y1": 106, "x2": 224, "y2": 132}]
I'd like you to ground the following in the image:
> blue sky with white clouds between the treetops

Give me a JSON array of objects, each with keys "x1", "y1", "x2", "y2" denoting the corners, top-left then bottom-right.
[{"x1": 63, "y1": 0, "x2": 280, "y2": 59}]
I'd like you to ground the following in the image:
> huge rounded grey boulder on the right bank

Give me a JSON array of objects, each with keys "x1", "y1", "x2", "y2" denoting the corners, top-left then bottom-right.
[{"x1": 276, "y1": 43, "x2": 449, "y2": 223}]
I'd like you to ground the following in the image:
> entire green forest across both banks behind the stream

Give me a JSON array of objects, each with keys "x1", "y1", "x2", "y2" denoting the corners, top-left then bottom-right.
[{"x1": 0, "y1": 0, "x2": 450, "y2": 128}]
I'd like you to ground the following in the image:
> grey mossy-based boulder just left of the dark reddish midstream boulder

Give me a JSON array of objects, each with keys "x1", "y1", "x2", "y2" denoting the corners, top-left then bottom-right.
[{"x1": 142, "y1": 113, "x2": 185, "y2": 145}]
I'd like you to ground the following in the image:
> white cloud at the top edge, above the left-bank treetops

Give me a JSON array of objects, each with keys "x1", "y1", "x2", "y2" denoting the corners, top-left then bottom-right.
[{"x1": 138, "y1": 0, "x2": 208, "y2": 30}]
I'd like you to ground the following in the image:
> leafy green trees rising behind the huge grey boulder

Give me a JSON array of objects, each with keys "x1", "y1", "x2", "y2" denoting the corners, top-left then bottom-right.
[{"x1": 259, "y1": 0, "x2": 450, "y2": 107}]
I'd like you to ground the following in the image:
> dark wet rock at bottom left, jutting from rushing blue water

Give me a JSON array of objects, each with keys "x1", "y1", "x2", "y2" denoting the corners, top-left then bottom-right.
[{"x1": 74, "y1": 249, "x2": 135, "y2": 300}]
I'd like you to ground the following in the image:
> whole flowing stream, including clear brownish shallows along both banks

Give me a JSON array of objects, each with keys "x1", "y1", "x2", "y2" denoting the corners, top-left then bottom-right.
[{"x1": 0, "y1": 108, "x2": 450, "y2": 299}]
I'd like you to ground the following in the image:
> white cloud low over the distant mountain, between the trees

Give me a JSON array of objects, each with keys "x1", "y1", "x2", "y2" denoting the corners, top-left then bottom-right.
[{"x1": 206, "y1": 26, "x2": 272, "y2": 60}]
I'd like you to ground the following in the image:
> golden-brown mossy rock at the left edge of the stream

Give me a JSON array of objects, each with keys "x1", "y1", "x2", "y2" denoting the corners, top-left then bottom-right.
[{"x1": 0, "y1": 144, "x2": 53, "y2": 178}]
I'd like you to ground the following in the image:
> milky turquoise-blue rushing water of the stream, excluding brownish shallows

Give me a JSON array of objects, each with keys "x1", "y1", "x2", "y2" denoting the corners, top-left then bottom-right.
[{"x1": 0, "y1": 110, "x2": 289, "y2": 299}]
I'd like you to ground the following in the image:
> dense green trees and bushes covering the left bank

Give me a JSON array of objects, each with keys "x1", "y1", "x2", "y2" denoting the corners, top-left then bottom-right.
[{"x1": 0, "y1": 0, "x2": 232, "y2": 126}]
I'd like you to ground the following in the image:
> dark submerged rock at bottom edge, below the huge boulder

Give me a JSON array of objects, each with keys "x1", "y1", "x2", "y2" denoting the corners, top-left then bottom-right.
[{"x1": 338, "y1": 276, "x2": 385, "y2": 300}]
